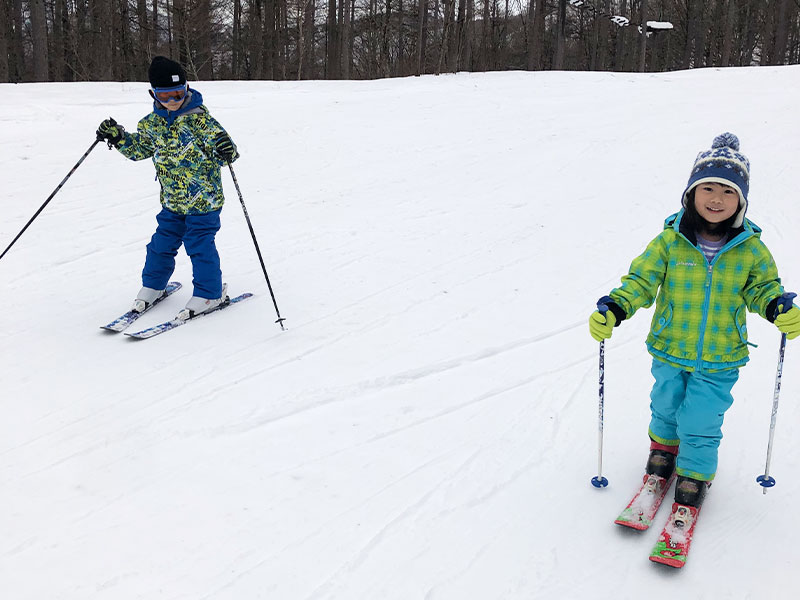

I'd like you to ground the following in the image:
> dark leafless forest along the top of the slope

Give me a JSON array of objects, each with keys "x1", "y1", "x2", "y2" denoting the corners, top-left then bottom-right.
[{"x1": 0, "y1": 0, "x2": 800, "y2": 82}]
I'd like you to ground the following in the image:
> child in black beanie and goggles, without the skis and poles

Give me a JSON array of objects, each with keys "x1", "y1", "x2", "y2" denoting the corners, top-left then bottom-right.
[{"x1": 97, "y1": 56, "x2": 239, "y2": 320}]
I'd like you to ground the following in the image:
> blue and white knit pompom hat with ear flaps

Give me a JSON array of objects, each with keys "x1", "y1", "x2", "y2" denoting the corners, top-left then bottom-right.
[{"x1": 683, "y1": 133, "x2": 750, "y2": 228}]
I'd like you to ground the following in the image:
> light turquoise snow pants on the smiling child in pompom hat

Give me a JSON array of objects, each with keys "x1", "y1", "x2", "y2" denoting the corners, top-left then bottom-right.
[{"x1": 650, "y1": 359, "x2": 739, "y2": 481}]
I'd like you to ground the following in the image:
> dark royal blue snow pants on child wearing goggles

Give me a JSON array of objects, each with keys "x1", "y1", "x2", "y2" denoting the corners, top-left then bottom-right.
[{"x1": 142, "y1": 208, "x2": 222, "y2": 299}]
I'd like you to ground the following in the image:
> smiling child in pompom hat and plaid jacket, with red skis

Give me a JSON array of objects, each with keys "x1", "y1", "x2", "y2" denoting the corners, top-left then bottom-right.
[{"x1": 589, "y1": 133, "x2": 800, "y2": 566}]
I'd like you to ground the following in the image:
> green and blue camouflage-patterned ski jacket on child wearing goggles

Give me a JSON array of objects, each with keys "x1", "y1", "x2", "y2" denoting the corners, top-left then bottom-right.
[{"x1": 117, "y1": 90, "x2": 238, "y2": 215}]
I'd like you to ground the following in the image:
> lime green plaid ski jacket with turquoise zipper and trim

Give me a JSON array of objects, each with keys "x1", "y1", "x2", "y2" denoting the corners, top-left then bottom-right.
[{"x1": 610, "y1": 211, "x2": 783, "y2": 372}]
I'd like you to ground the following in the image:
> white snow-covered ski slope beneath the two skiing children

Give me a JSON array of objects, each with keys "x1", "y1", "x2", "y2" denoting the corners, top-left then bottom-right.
[{"x1": 0, "y1": 67, "x2": 800, "y2": 600}]
